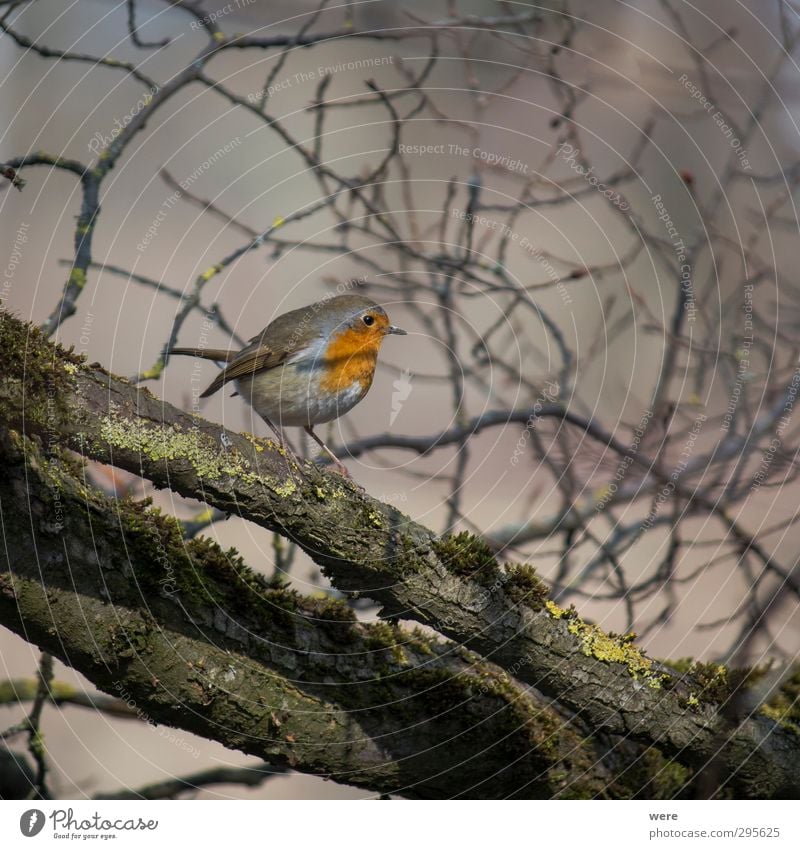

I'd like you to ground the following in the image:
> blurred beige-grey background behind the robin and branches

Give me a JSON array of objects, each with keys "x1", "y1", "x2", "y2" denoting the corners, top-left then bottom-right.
[{"x1": 0, "y1": 0, "x2": 800, "y2": 798}]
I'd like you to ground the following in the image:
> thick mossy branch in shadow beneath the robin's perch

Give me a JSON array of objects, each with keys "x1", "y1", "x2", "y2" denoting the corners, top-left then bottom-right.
[{"x1": 0, "y1": 420, "x2": 606, "y2": 798}]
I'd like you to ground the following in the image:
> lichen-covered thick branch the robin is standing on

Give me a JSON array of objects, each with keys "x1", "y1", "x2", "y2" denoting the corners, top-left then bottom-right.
[{"x1": 0, "y1": 310, "x2": 800, "y2": 796}]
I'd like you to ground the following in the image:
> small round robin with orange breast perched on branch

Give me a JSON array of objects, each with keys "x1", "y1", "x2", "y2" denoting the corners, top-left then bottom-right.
[{"x1": 171, "y1": 295, "x2": 406, "y2": 474}]
